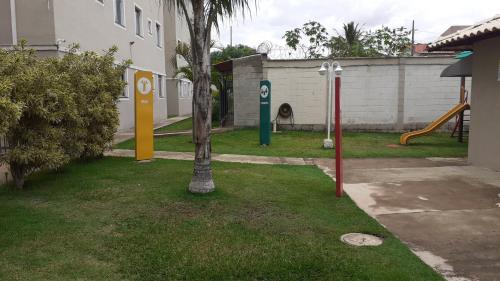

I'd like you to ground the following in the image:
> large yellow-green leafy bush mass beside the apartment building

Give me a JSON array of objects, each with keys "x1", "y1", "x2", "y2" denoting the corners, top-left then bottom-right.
[{"x1": 0, "y1": 42, "x2": 128, "y2": 188}]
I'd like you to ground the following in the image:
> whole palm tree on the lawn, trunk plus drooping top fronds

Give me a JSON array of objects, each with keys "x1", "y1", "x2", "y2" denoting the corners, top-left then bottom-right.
[{"x1": 164, "y1": 0, "x2": 256, "y2": 193}]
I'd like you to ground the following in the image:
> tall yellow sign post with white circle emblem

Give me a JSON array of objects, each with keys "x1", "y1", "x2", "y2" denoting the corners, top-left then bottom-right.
[{"x1": 134, "y1": 71, "x2": 154, "y2": 161}]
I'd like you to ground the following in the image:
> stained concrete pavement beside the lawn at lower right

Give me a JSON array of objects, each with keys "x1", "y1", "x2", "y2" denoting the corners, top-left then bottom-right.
[{"x1": 316, "y1": 158, "x2": 500, "y2": 281}]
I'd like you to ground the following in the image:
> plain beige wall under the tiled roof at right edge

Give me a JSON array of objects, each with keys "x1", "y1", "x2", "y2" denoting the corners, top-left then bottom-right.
[{"x1": 469, "y1": 37, "x2": 500, "y2": 171}]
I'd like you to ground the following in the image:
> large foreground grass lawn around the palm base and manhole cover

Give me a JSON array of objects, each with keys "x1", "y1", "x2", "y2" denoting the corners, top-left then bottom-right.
[{"x1": 0, "y1": 158, "x2": 443, "y2": 281}]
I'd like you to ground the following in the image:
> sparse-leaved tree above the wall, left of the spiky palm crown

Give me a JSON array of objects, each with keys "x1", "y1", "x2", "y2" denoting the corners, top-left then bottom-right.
[{"x1": 283, "y1": 21, "x2": 328, "y2": 59}]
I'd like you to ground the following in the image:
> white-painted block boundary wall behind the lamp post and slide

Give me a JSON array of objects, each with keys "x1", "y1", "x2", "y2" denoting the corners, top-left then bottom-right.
[{"x1": 233, "y1": 56, "x2": 468, "y2": 131}]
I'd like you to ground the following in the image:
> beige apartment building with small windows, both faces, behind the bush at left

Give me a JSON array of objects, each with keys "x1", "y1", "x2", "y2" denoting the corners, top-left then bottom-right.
[{"x1": 0, "y1": 0, "x2": 189, "y2": 131}]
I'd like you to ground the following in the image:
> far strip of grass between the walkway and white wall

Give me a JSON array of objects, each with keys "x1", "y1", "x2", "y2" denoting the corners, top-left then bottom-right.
[{"x1": 117, "y1": 129, "x2": 467, "y2": 158}]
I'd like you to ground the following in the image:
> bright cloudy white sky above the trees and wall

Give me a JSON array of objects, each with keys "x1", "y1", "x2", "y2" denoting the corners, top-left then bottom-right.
[{"x1": 215, "y1": 0, "x2": 500, "y2": 48}]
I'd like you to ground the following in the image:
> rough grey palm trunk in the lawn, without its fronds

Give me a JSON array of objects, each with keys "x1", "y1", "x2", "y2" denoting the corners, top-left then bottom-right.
[{"x1": 189, "y1": 1, "x2": 215, "y2": 193}]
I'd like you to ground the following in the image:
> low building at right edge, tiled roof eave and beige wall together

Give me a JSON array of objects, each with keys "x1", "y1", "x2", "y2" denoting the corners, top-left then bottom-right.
[{"x1": 431, "y1": 14, "x2": 500, "y2": 171}]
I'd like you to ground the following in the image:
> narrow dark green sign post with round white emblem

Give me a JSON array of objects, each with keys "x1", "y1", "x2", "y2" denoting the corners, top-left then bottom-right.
[{"x1": 260, "y1": 80, "x2": 271, "y2": 145}]
